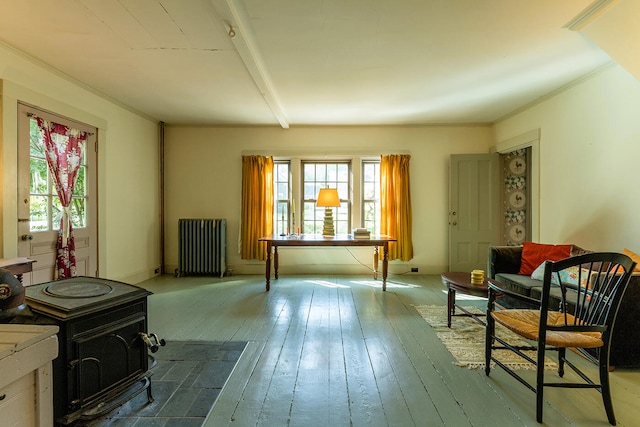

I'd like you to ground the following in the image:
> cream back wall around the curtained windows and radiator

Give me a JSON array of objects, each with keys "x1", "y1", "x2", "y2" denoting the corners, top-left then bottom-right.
[{"x1": 165, "y1": 126, "x2": 493, "y2": 274}]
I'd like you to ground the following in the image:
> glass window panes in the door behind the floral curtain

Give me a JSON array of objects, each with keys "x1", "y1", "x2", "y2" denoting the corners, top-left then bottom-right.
[{"x1": 29, "y1": 117, "x2": 87, "y2": 231}]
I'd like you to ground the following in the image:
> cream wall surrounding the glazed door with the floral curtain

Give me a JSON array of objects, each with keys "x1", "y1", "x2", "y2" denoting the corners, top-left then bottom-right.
[{"x1": 0, "y1": 45, "x2": 160, "y2": 283}]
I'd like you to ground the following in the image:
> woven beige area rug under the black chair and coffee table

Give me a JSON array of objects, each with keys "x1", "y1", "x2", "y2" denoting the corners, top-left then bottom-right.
[{"x1": 414, "y1": 305, "x2": 557, "y2": 370}]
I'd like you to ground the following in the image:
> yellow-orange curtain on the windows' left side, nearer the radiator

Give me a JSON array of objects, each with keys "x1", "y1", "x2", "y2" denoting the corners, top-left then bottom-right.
[{"x1": 240, "y1": 156, "x2": 273, "y2": 260}]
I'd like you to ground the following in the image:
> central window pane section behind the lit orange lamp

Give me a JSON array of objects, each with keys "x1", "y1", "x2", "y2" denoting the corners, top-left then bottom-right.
[{"x1": 302, "y1": 161, "x2": 351, "y2": 234}]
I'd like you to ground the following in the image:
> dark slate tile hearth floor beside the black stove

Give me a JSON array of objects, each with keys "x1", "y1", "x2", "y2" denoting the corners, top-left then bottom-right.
[{"x1": 86, "y1": 341, "x2": 247, "y2": 427}]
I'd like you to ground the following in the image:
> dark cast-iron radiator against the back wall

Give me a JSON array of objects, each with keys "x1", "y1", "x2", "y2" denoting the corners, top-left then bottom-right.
[{"x1": 176, "y1": 218, "x2": 227, "y2": 277}]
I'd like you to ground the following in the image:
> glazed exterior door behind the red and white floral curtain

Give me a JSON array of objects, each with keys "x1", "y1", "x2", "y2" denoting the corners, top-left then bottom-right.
[{"x1": 18, "y1": 104, "x2": 98, "y2": 285}]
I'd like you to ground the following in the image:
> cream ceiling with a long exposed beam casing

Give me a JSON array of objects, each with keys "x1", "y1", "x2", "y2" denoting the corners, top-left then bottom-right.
[{"x1": 0, "y1": 0, "x2": 611, "y2": 127}]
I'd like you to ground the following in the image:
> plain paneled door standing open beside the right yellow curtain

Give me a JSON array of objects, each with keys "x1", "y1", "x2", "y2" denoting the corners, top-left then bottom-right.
[{"x1": 449, "y1": 154, "x2": 500, "y2": 272}]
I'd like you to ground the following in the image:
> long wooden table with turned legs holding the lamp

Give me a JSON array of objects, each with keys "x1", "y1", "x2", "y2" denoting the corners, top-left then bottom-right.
[{"x1": 258, "y1": 234, "x2": 397, "y2": 291}]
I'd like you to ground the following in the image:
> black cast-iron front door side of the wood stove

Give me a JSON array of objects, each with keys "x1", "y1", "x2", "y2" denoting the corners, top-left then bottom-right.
[{"x1": 69, "y1": 313, "x2": 148, "y2": 410}]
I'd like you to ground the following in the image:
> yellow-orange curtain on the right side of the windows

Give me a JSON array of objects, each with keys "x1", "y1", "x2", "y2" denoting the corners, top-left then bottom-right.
[{"x1": 380, "y1": 154, "x2": 413, "y2": 261}]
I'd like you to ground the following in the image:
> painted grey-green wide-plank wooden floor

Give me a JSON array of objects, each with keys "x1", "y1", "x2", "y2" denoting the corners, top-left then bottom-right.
[{"x1": 140, "y1": 275, "x2": 640, "y2": 427}]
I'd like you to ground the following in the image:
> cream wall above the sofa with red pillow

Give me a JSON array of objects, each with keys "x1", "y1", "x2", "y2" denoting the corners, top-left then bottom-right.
[{"x1": 495, "y1": 65, "x2": 640, "y2": 252}]
